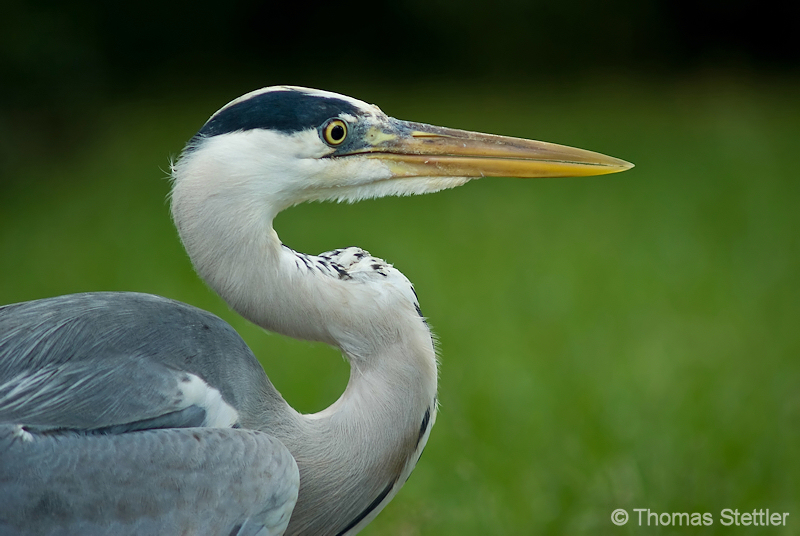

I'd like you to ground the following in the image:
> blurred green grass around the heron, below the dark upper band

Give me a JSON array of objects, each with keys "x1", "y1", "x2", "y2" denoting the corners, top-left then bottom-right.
[{"x1": 0, "y1": 78, "x2": 800, "y2": 535}]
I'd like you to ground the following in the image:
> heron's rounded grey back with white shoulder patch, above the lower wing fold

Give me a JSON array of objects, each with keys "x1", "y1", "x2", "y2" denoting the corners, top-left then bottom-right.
[{"x1": 0, "y1": 293, "x2": 274, "y2": 431}]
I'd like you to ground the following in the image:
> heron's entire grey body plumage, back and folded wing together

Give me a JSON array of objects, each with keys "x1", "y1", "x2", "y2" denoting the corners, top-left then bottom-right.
[{"x1": 0, "y1": 293, "x2": 299, "y2": 536}]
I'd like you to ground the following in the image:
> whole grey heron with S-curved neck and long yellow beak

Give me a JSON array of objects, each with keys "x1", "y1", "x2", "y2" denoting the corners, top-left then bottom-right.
[{"x1": 0, "y1": 86, "x2": 631, "y2": 535}]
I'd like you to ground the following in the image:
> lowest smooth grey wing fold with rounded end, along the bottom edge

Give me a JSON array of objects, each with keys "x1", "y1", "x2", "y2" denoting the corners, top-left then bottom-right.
[{"x1": 0, "y1": 425, "x2": 300, "y2": 536}]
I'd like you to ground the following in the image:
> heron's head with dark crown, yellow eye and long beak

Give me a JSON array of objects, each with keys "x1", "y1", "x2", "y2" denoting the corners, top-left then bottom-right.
[{"x1": 173, "y1": 86, "x2": 632, "y2": 213}]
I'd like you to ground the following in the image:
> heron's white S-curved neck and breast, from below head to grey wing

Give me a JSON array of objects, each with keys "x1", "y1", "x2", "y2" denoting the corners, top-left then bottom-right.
[{"x1": 173, "y1": 172, "x2": 437, "y2": 535}]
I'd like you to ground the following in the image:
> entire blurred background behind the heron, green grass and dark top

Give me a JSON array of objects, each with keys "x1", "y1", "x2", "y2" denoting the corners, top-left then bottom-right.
[{"x1": 0, "y1": 0, "x2": 800, "y2": 535}]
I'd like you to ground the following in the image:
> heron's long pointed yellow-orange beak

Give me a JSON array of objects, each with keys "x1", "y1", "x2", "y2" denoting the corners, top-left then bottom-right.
[{"x1": 357, "y1": 119, "x2": 633, "y2": 178}]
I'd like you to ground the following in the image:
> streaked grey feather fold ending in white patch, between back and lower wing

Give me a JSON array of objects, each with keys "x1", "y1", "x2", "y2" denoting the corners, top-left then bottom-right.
[{"x1": 0, "y1": 355, "x2": 222, "y2": 433}]
